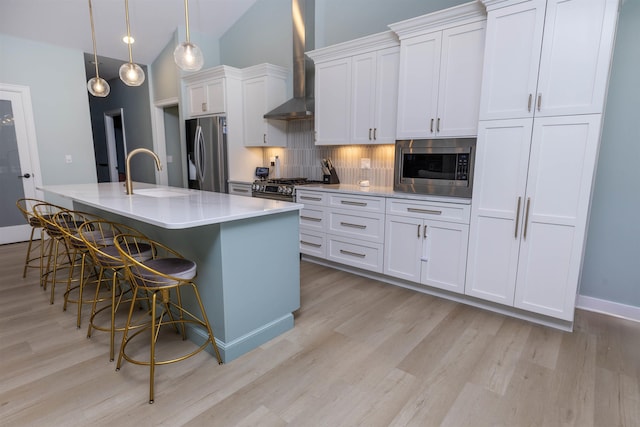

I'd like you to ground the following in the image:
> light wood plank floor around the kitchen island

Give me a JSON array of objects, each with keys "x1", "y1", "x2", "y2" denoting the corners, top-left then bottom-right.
[{"x1": 0, "y1": 244, "x2": 640, "y2": 427}]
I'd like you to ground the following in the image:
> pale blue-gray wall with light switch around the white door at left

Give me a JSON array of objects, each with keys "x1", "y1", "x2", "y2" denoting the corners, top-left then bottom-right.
[{"x1": 0, "y1": 34, "x2": 96, "y2": 185}]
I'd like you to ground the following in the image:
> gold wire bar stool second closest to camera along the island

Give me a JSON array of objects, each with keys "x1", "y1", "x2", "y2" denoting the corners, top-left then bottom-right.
[{"x1": 78, "y1": 220, "x2": 151, "y2": 362}]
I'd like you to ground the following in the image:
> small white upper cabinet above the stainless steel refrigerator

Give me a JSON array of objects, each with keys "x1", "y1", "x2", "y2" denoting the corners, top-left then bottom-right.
[{"x1": 184, "y1": 65, "x2": 241, "y2": 117}]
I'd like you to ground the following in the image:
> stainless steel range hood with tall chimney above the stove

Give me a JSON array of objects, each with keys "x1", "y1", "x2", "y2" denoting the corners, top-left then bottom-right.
[{"x1": 264, "y1": 0, "x2": 315, "y2": 120}]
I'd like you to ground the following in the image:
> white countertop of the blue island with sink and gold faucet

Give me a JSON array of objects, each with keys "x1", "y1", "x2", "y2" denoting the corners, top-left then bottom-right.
[{"x1": 39, "y1": 182, "x2": 303, "y2": 229}]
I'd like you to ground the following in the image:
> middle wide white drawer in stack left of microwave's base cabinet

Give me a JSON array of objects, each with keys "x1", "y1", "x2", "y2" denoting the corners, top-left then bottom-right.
[{"x1": 327, "y1": 209, "x2": 384, "y2": 243}]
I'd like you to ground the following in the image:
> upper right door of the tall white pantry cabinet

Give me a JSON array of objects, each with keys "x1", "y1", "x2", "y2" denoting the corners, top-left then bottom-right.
[{"x1": 536, "y1": 0, "x2": 618, "y2": 116}]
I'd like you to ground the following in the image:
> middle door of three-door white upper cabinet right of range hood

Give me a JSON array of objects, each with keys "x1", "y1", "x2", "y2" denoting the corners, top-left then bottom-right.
[{"x1": 351, "y1": 52, "x2": 376, "y2": 144}]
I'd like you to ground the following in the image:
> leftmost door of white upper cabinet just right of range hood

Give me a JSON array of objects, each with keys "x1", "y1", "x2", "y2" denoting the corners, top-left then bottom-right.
[{"x1": 315, "y1": 58, "x2": 351, "y2": 145}]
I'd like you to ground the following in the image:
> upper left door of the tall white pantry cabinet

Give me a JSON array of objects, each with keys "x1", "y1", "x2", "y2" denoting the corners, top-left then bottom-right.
[{"x1": 480, "y1": 0, "x2": 544, "y2": 120}]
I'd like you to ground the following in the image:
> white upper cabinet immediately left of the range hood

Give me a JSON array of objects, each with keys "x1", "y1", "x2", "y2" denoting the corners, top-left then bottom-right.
[{"x1": 242, "y1": 64, "x2": 287, "y2": 147}]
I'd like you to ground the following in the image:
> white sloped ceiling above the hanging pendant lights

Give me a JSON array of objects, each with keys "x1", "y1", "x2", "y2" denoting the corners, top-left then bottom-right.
[{"x1": 0, "y1": 0, "x2": 256, "y2": 78}]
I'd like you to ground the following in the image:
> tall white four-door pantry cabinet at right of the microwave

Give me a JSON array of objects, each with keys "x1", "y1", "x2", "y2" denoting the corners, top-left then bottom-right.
[{"x1": 465, "y1": 0, "x2": 618, "y2": 322}]
